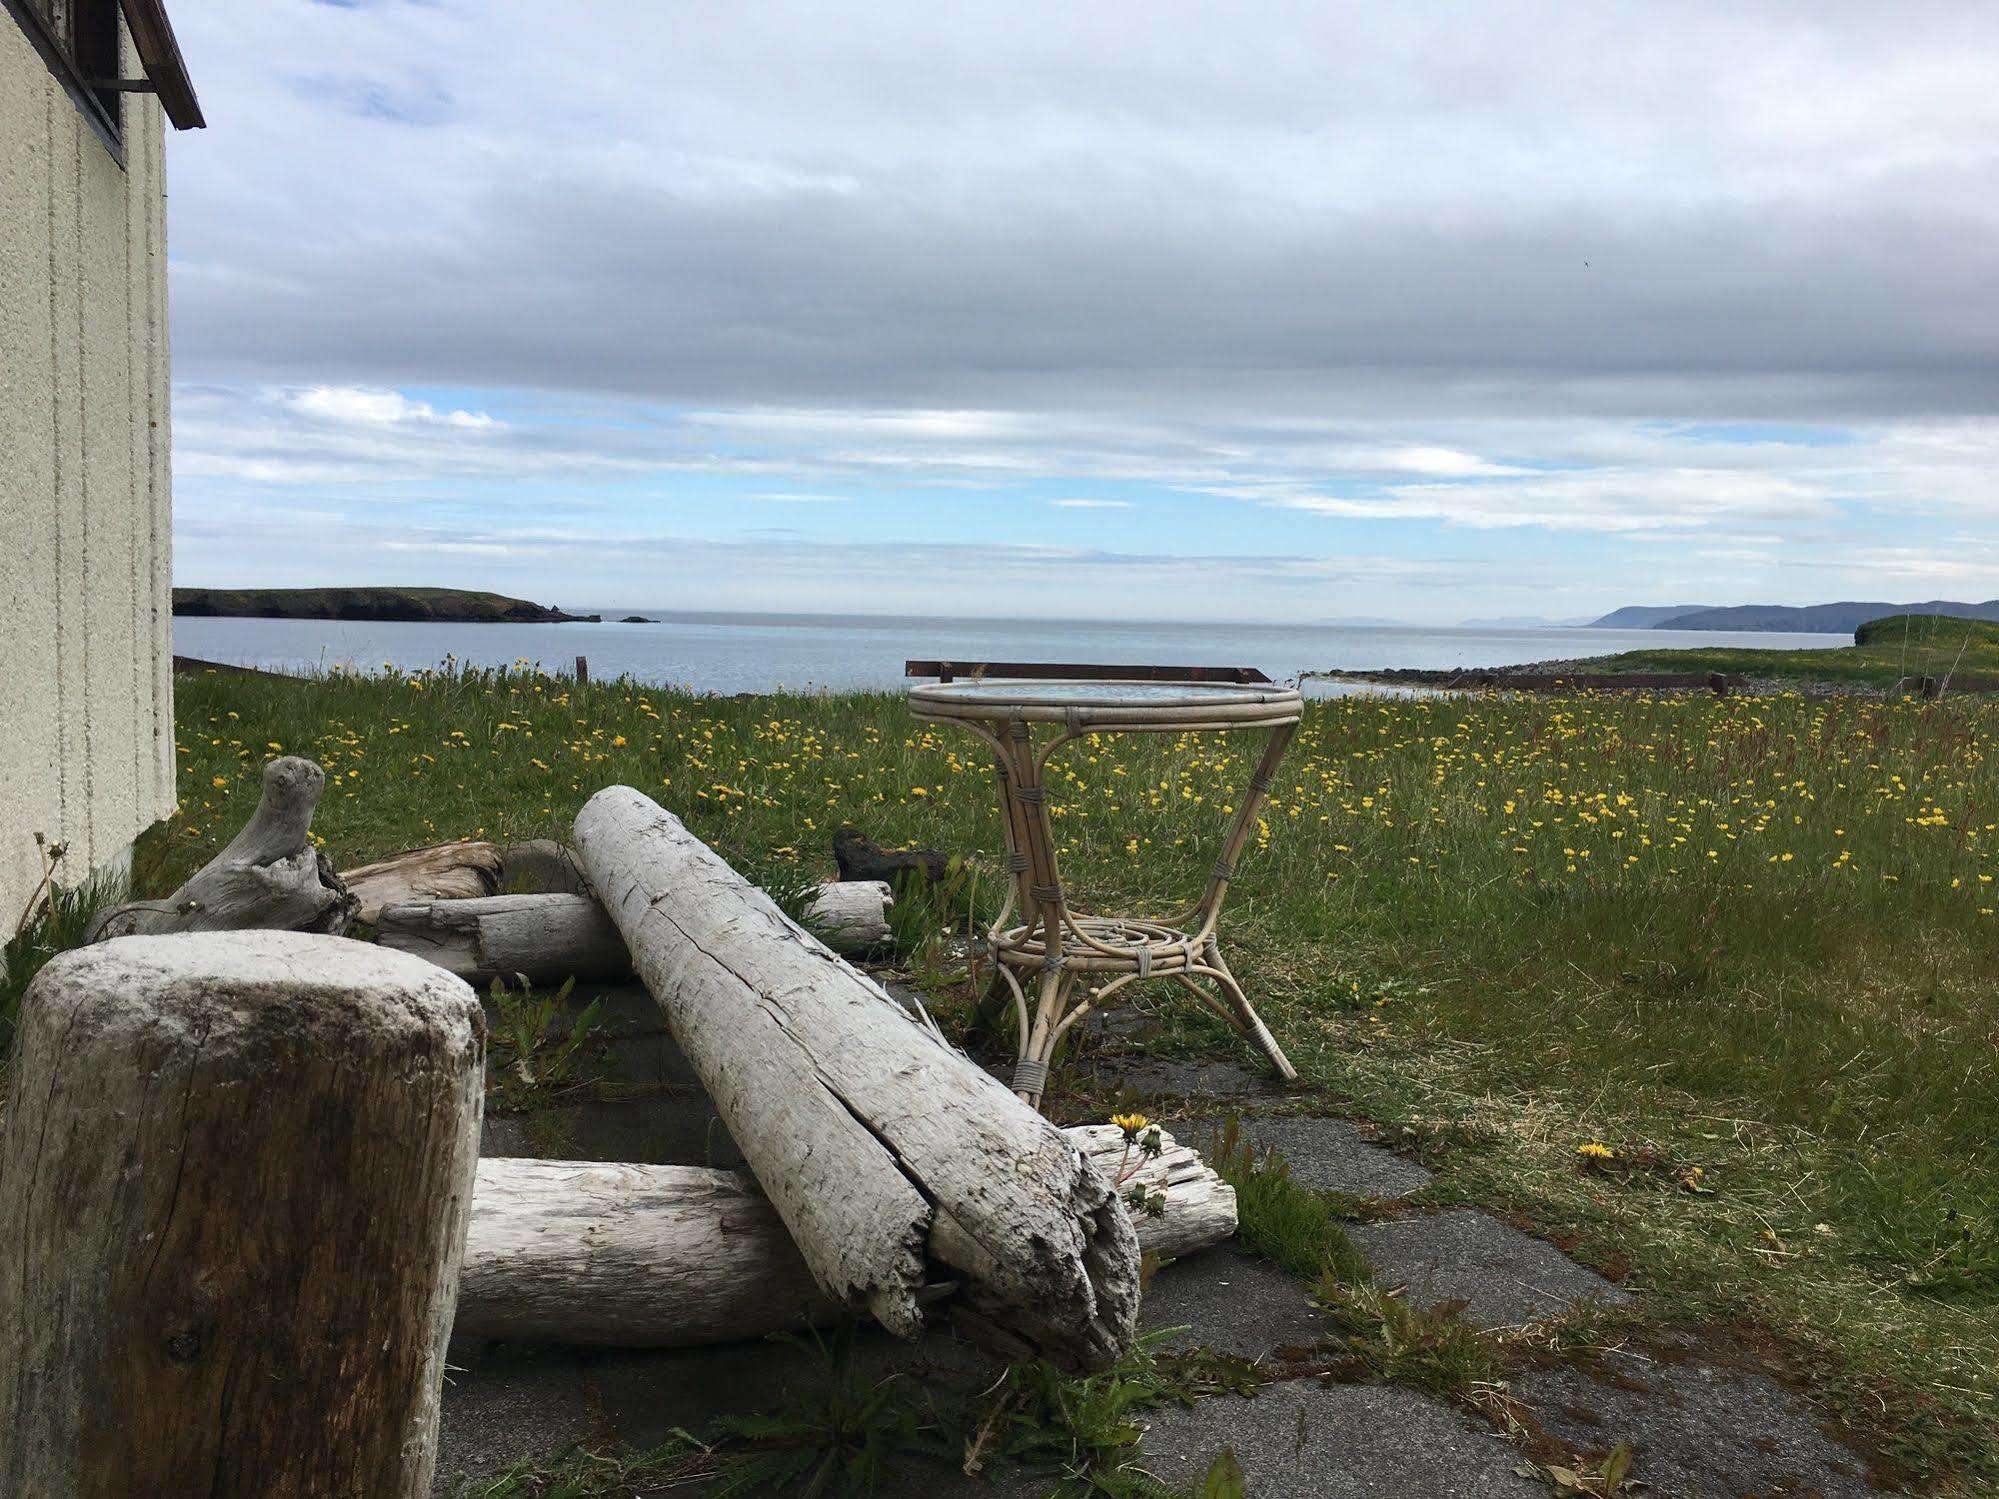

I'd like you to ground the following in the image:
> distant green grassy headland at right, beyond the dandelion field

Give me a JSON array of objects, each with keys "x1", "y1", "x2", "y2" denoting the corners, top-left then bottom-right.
[{"x1": 1571, "y1": 614, "x2": 1999, "y2": 688}]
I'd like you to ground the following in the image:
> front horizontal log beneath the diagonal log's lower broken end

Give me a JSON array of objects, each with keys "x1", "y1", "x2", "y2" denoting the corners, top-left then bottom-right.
[{"x1": 456, "y1": 1125, "x2": 1235, "y2": 1347}]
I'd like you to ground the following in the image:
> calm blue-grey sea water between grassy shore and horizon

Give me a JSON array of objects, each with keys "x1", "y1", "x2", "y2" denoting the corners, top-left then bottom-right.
[{"x1": 174, "y1": 608, "x2": 1849, "y2": 696}]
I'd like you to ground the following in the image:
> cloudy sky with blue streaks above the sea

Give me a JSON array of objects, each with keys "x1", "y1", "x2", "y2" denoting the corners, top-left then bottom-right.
[{"x1": 168, "y1": 0, "x2": 1999, "y2": 624}]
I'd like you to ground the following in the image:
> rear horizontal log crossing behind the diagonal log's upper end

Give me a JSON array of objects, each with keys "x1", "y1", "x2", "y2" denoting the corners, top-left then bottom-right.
[{"x1": 376, "y1": 881, "x2": 894, "y2": 983}]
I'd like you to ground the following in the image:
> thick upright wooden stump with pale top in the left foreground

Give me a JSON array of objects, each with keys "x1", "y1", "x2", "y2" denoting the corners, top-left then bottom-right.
[{"x1": 0, "y1": 931, "x2": 484, "y2": 1499}]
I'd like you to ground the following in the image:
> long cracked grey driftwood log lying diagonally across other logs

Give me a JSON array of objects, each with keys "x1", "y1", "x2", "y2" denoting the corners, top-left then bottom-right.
[{"x1": 576, "y1": 785, "x2": 1139, "y2": 1369}]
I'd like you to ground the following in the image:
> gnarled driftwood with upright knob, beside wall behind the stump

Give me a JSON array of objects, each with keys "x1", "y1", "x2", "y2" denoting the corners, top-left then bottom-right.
[{"x1": 86, "y1": 755, "x2": 358, "y2": 941}]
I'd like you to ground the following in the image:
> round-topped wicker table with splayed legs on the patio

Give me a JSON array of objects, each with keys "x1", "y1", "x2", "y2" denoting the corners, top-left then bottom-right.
[{"x1": 910, "y1": 682, "x2": 1301, "y2": 1107}]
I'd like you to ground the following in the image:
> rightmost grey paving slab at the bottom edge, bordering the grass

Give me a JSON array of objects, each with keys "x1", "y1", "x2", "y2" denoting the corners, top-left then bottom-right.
[{"x1": 1513, "y1": 1353, "x2": 1883, "y2": 1499}]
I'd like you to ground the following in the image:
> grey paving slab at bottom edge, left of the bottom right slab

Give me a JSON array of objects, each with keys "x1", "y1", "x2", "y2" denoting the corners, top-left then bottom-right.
[{"x1": 1139, "y1": 1379, "x2": 1547, "y2": 1499}]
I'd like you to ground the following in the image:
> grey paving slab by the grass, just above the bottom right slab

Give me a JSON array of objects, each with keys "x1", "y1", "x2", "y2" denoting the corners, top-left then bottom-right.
[{"x1": 1347, "y1": 1207, "x2": 1631, "y2": 1327}]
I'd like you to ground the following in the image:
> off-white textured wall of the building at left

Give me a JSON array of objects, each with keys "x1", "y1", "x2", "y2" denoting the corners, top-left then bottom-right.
[{"x1": 0, "y1": 14, "x2": 174, "y2": 935}]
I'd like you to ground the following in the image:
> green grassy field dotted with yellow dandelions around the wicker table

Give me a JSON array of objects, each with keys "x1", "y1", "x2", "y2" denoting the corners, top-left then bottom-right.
[{"x1": 27, "y1": 674, "x2": 1999, "y2": 1491}]
